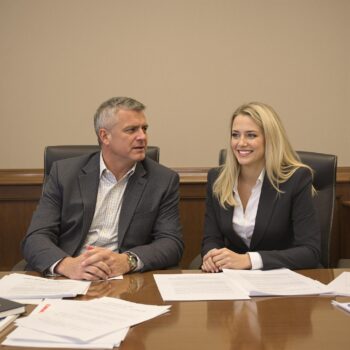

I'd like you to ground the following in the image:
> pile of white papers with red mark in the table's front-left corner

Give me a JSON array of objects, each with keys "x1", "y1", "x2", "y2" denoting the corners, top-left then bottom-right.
[{"x1": 2, "y1": 297, "x2": 170, "y2": 349}]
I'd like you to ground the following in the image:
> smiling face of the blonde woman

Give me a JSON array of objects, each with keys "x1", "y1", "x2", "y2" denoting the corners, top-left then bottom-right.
[{"x1": 231, "y1": 114, "x2": 265, "y2": 169}]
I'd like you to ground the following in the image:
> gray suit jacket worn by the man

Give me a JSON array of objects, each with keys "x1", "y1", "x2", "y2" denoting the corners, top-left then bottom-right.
[{"x1": 22, "y1": 152, "x2": 183, "y2": 272}]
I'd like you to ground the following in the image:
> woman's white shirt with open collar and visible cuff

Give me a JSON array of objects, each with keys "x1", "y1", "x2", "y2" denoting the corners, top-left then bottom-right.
[{"x1": 232, "y1": 169, "x2": 265, "y2": 270}]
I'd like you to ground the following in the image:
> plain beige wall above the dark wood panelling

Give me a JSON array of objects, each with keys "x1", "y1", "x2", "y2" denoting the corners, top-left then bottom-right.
[{"x1": 0, "y1": 0, "x2": 350, "y2": 169}]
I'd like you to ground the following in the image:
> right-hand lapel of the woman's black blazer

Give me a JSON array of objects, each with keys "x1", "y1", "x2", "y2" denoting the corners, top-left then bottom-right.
[{"x1": 250, "y1": 175, "x2": 277, "y2": 250}]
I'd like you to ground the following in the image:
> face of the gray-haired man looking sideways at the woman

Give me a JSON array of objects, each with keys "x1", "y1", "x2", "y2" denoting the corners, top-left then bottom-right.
[{"x1": 100, "y1": 109, "x2": 148, "y2": 164}]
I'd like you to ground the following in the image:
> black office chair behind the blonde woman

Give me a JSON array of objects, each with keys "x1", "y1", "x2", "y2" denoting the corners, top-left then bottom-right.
[{"x1": 190, "y1": 149, "x2": 338, "y2": 268}]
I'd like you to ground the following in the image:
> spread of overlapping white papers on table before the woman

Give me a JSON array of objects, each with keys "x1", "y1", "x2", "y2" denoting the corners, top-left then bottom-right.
[{"x1": 154, "y1": 269, "x2": 330, "y2": 300}]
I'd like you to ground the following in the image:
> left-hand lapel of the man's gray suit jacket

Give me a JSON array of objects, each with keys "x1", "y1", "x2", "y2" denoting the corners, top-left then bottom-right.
[{"x1": 78, "y1": 152, "x2": 100, "y2": 246}]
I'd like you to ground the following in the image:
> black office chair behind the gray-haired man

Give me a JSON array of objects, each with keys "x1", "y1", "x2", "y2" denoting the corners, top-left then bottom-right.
[{"x1": 12, "y1": 145, "x2": 160, "y2": 271}]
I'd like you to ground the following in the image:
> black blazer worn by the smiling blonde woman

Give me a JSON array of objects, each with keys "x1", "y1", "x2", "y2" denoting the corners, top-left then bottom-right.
[{"x1": 202, "y1": 168, "x2": 321, "y2": 269}]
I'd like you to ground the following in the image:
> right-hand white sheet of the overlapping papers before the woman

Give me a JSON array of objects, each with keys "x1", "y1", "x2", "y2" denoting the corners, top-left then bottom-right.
[{"x1": 224, "y1": 269, "x2": 329, "y2": 296}]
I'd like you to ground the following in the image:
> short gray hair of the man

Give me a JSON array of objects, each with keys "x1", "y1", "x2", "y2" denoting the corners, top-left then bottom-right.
[{"x1": 94, "y1": 97, "x2": 146, "y2": 142}]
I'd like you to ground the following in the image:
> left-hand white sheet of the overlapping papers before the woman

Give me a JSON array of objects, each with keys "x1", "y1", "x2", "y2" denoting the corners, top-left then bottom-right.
[{"x1": 153, "y1": 273, "x2": 250, "y2": 300}]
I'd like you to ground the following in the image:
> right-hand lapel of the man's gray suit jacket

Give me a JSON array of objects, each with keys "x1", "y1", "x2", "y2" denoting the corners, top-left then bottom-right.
[{"x1": 118, "y1": 162, "x2": 147, "y2": 247}]
